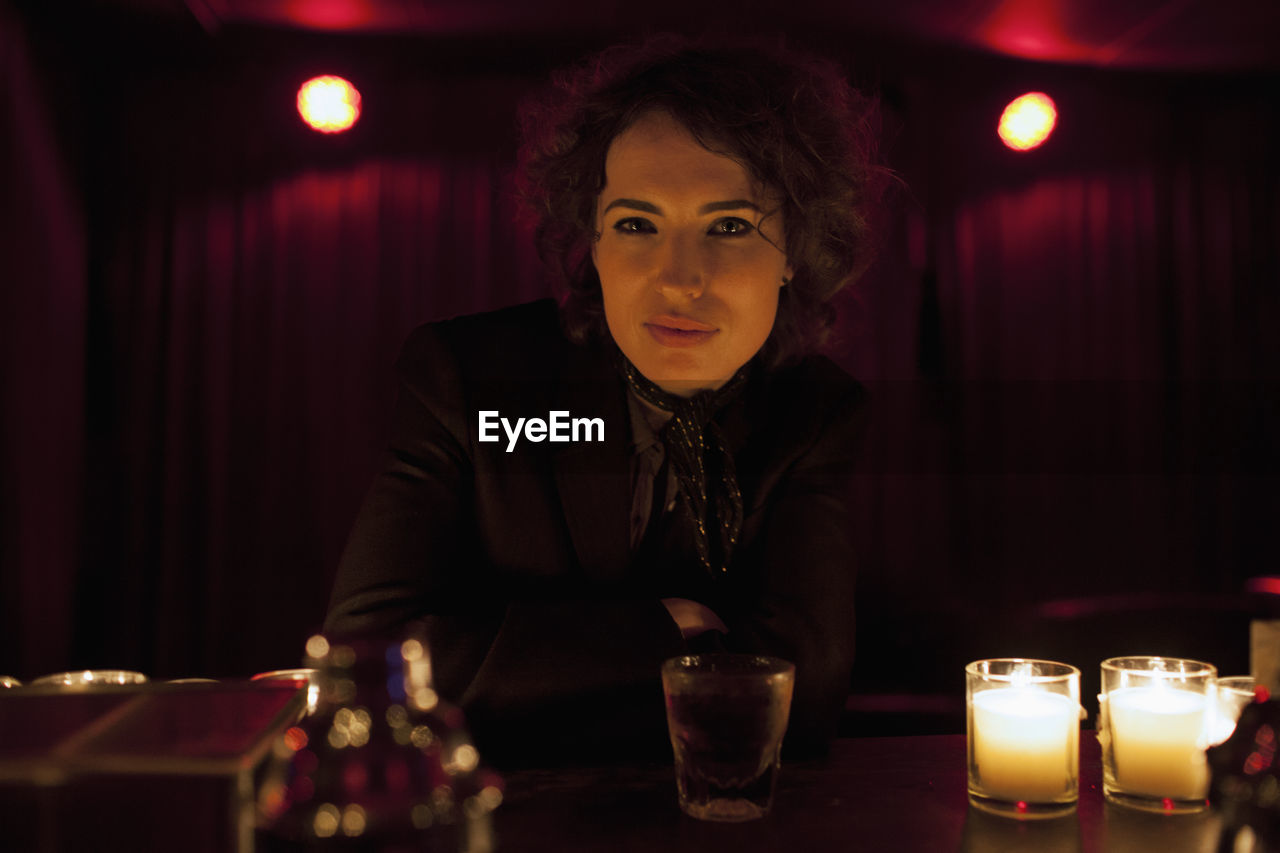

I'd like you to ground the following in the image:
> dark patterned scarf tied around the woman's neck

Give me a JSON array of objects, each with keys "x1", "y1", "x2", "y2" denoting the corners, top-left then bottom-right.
[{"x1": 618, "y1": 352, "x2": 746, "y2": 576}]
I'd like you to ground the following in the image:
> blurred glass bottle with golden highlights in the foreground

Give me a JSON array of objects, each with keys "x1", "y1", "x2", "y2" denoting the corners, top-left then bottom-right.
[{"x1": 256, "y1": 627, "x2": 502, "y2": 853}]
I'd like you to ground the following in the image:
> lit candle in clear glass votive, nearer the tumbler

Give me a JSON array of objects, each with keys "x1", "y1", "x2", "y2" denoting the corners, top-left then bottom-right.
[{"x1": 965, "y1": 658, "x2": 1082, "y2": 818}]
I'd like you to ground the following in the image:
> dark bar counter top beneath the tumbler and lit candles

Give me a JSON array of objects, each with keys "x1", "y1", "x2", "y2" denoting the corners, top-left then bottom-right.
[{"x1": 494, "y1": 731, "x2": 1220, "y2": 853}]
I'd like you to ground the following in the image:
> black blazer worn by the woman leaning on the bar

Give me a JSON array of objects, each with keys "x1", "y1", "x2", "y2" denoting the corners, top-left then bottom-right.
[{"x1": 325, "y1": 300, "x2": 864, "y2": 760}]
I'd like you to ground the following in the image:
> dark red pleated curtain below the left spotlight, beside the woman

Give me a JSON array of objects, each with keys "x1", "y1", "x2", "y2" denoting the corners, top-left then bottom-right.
[{"x1": 77, "y1": 156, "x2": 547, "y2": 675}]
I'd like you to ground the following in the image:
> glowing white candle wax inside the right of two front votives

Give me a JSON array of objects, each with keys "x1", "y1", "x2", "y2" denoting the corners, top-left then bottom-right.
[{"x1": 1107, "y1": 685, "x2": 1208, "y2": 799}]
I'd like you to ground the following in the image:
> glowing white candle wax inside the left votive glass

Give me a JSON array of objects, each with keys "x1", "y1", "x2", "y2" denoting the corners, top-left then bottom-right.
[{"x1": 973, "y1": 686, "x2": 1080, "y2": 803}]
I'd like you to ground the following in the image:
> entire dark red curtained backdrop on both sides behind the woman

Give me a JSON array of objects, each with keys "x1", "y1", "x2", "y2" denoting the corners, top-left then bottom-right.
[{"x1": 0, "y1": 0, "x2": 1280, "y2": 717}]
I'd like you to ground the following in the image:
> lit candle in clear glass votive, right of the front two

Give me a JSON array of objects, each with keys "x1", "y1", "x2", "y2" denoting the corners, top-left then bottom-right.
[{"x1": 1098, "y1": 656, "x2": 1217, "y2": 813}]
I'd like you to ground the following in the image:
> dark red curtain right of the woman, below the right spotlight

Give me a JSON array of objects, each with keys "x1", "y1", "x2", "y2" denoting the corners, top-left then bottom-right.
[{"x1": 846, "y1": 70, "x2": 1280, "y2": 686}]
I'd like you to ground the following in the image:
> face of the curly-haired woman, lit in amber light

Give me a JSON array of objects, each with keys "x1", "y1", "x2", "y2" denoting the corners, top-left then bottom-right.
[{"x1": 591, "y1": 113, "x2": 791, "y2": 397}]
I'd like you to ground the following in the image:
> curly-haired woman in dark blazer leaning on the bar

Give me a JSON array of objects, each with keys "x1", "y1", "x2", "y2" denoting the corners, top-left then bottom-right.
[{"x1": 326, "y1": 40, "x2": 874, "y2": 761}]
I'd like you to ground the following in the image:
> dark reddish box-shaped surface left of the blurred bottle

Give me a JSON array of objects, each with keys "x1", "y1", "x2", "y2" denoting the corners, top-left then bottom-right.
[{"x1": 0, "y1": 681, "x2": 306, "y2": 853}]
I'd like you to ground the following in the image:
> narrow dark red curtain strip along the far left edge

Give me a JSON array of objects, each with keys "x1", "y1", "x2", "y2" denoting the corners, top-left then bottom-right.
[{"x1": 0, "y1": 5, "x2": 87, "y2": 678}]
